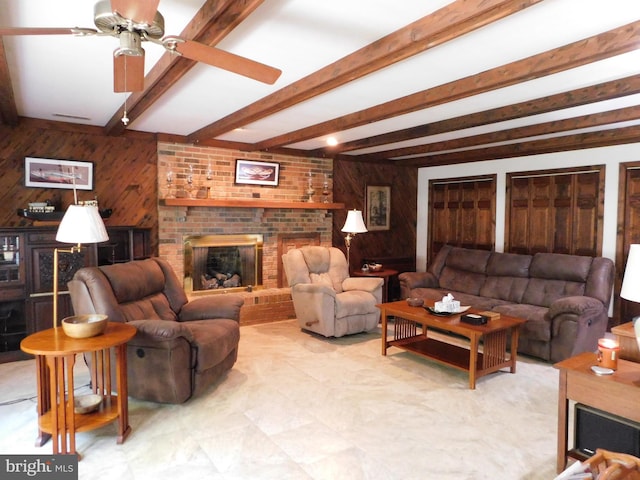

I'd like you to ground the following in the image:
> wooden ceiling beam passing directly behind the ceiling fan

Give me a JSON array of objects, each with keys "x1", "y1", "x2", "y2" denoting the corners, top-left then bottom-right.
[{"x1": 105, "y1": 0, "x2": 264, "y2": 135}]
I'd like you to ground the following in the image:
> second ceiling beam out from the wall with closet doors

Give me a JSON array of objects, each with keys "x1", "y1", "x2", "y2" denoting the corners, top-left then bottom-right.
[{"x1": 357, "y1": 106, "x2": 640, "y2": 160}]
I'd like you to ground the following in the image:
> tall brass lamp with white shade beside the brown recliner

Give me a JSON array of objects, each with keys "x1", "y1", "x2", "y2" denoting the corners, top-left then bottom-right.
[{"x1": 53, "y1": 205, "x2": 109, "y2": 328}]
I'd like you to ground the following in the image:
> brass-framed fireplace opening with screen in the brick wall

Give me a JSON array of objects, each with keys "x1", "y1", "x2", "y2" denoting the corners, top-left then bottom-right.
[{"x1": 184, "y1": 235, "x2": 262, "y2": 291}]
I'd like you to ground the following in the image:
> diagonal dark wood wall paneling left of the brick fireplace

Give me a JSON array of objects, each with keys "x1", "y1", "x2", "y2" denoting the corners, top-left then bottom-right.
[{"x1": 0, "y1": 119, "x2": 158, "y2": 253}]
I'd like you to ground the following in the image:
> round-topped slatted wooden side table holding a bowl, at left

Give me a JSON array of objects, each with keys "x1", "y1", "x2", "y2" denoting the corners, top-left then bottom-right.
[{"x1": 20, "y1": 322, "x2": 136, "y2": 454}]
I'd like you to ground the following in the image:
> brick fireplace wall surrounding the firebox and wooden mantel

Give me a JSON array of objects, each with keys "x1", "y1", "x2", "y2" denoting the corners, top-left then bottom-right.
[{"x1": 158, "y1": 142, "x2": 333, "y2": 322}]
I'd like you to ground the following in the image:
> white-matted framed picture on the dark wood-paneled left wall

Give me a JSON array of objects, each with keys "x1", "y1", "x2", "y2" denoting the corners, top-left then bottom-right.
[{"x1": 24, "y1": 157, "x2": 93, "y2": 190}]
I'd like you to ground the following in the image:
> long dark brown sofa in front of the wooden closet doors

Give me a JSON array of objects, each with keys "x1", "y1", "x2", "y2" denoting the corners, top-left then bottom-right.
[{"x1": 399, "y1": 245, "x2": 614, "y2": 362}]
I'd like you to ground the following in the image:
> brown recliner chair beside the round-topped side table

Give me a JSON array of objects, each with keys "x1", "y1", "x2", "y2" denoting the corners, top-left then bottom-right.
[{"x1": 69, "y1": 258, "x2": 243, "y2": 403}]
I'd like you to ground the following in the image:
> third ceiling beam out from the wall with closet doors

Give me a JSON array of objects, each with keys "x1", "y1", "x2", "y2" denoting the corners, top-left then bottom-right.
[{"x1": 310, "y1": 75, "x2": 640, "y2": 158}]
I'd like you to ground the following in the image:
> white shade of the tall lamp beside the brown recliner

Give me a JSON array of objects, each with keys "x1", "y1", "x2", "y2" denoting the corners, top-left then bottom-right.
[{"x1": 56, "y1": 205, "x2": 109, "y2": 244}]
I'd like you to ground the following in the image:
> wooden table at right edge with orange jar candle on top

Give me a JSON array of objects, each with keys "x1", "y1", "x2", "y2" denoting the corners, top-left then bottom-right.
[{"x1": 554, "y1": 352, "x2": 640, "y2": 473}]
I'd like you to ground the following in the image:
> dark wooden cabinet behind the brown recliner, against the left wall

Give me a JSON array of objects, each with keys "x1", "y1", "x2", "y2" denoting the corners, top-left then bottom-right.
[{"x1": 0, "y1": 226, "x2": 152, "y2": 363}]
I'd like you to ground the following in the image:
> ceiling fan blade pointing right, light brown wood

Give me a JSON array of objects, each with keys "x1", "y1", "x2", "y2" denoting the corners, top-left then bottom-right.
[{"x1": 176, "y1": 40, "x2": 282, "y2": 85}]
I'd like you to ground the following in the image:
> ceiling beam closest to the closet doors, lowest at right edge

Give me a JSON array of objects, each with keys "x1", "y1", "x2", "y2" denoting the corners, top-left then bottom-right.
[{"x1": 398, "y1": 125, "x2": 640, "y2": 168}]
